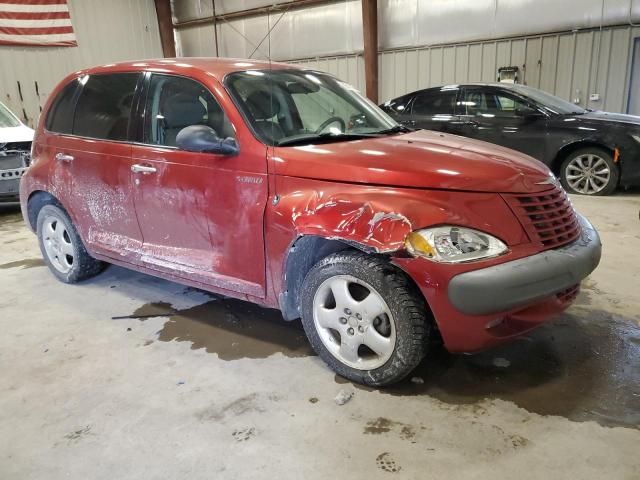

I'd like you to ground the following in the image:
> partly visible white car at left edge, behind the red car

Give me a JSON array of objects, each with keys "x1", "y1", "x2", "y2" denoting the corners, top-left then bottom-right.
[{"x1": 0, "y1": 103, "x2": 33, "y2": 202}]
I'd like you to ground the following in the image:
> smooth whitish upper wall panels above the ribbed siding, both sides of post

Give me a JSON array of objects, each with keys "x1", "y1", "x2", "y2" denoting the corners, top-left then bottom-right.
[{"x1": 172, "y1": 0, "x2": 640, "y2": 60}]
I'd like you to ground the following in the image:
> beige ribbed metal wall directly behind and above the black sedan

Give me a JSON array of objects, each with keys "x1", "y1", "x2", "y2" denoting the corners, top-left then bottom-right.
[{"x1": 291, "y1": 26, "x2": 640, "y2": 112}]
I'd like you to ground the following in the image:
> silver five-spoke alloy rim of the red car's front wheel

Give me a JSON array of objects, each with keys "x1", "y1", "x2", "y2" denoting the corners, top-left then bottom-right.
[{"x1": 313, "y1": 275, "x2": 396, "y2": 370}]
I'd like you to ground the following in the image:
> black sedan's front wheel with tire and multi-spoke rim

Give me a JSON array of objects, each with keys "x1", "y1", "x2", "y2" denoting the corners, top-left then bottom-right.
[{"x1": 560, "y1": 147, "x2": 620, "y2": 195}]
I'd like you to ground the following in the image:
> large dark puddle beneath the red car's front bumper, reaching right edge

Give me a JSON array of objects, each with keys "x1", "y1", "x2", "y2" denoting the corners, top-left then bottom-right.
[{"x1": 335, "y1": 309, "x2": 640, "y2": 428}]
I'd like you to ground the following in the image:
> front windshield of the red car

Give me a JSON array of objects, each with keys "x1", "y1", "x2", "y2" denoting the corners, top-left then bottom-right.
[{"x1": 225, "y1": 70, "x2": 402, "y2": 145}]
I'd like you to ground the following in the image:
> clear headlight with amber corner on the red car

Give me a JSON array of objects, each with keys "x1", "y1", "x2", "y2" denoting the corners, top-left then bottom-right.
[{"x1": 405, "y1": 225, "x2": 507, "y2": 263}]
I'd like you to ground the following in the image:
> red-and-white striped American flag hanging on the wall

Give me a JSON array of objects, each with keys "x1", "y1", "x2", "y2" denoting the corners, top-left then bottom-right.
[{"x1": 0, "y1": 0, "x2": 78, "y2": 47}]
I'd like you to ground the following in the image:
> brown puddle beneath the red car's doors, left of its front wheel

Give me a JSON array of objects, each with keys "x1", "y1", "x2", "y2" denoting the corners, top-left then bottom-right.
[{"x1": 120, "y1": 298, "x2": 314, "y2": 360}]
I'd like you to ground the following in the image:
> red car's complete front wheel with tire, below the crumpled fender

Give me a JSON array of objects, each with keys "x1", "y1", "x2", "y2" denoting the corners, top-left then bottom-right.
[{"x1": 300, "y1": 251, "x2": 431, "y2": 386}]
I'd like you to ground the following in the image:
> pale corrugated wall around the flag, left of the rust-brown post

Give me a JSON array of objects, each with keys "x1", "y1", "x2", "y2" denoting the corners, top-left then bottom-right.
[{"x1": 0, "y1": 0, "x2": 162, "y2": 126}]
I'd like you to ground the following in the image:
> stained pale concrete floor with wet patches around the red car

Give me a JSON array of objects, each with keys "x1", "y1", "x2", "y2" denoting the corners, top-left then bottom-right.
[{"x1": 0, "y1": 192, "x2": 640, "y2": 480}]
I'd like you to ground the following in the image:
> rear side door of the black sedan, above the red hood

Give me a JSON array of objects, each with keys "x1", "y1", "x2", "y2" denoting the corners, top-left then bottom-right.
[{"x1": 401, "y1": 86, "x2": 459, "y2": 133}]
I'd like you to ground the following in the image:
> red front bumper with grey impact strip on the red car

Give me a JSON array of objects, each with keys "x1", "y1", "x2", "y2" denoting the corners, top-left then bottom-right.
[{"x1": 394, "y1": 216, "x2": 602, "y2": 352}]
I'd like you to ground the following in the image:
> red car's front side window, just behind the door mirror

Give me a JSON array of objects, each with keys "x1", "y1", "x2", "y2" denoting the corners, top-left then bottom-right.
[{"x1": 144, "y1": 74, "x2": 235, "y2": 147}]
